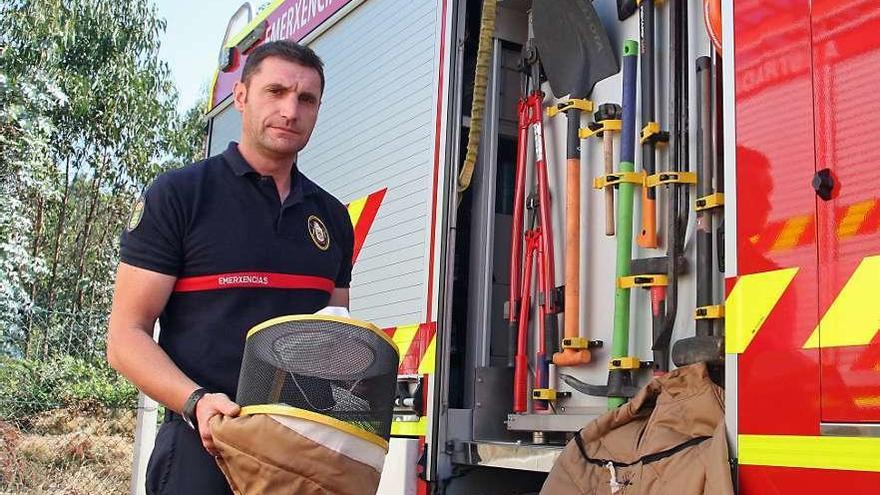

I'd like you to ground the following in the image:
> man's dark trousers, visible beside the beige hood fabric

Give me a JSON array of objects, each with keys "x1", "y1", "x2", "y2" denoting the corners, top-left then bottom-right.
[{"x1": 146, "y1": 414, "x2": 232, "y2": 495}]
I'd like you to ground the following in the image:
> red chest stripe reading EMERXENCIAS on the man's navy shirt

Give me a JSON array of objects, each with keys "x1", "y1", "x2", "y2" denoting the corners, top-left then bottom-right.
[{"x1": 174, "y1": 272, "x2": 336, "y2": 294}]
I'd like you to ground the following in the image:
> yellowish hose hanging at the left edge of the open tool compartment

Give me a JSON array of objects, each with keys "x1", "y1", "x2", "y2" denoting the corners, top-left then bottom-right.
[{"x1": 458, "y1": 0, "x2": 498, "y2": 197}]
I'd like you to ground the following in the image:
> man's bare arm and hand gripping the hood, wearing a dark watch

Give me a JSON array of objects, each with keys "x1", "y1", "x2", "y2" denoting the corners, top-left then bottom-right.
[{"x1": 107, "y1": 263, "x2": 239, "y2": 454}]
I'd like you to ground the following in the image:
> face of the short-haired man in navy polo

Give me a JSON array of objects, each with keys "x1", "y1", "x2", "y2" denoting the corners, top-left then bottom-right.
[{"x1": 233, "y1": 57, "x2": 321, "y2": 158}]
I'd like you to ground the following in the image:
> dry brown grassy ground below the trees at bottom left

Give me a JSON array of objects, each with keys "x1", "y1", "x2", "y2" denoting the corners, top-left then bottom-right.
[{"x1": 0, "y1": 407, "x2": 136, "y2": 495}]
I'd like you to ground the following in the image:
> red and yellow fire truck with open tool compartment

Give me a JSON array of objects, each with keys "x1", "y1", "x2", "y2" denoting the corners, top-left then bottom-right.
[{"x1": 158, "y1": 0, "x2": 880, "y2": 495}]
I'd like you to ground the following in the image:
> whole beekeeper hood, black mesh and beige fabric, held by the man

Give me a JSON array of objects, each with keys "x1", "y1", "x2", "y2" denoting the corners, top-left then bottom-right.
[{"x1": 211, "y1": 315, "x2": 399, "y2": 495}]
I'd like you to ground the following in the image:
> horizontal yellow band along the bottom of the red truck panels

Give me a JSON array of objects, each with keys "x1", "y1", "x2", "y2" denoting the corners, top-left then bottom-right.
[{"x1": 739, "y1": 435, "x2": 880, "y2": 472}]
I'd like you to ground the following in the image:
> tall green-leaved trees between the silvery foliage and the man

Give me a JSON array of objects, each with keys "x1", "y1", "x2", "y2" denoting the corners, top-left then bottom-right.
[{"x1": 0, "y1": 0, "x2": 174, "y2": 322}]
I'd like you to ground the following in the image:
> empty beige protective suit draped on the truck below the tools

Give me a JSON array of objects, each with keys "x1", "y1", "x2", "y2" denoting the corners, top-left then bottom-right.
[{"x1": 541, "y1": 363, "x2": 733, "y2": 495}]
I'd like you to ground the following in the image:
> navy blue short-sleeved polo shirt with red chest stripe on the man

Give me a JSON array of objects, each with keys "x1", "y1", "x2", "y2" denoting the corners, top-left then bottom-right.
[{"x1": 120, "y1": 143, "x2": 354, "y2": 397}]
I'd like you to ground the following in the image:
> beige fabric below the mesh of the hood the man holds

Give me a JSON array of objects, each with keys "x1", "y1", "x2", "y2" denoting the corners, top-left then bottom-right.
[{"x1": 211, "y1": 414, "x2": 380, "y2": 495}]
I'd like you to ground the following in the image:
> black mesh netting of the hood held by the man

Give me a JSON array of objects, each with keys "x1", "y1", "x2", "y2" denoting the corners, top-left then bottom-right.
[{"x1": 236, "y1": 317, "x2": 399, "y2": 440}]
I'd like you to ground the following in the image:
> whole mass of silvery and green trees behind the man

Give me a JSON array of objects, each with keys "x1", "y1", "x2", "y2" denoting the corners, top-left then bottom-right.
[{"x1": 0, "y1": 0, "x2": 204, "y2": 368}]
